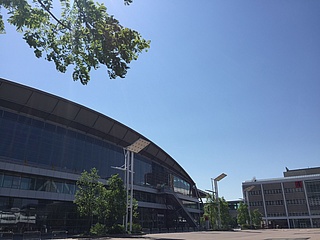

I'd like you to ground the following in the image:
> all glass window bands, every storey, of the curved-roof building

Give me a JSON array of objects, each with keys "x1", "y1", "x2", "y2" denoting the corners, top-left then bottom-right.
[{"x1": 0, "y1": 110, "x2": 198, "y2": 233}]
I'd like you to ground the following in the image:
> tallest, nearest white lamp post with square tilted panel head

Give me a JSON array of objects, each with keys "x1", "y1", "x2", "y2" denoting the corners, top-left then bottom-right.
[{"x1": 123, "y1": 138, "x2": 150, "y2": 232}]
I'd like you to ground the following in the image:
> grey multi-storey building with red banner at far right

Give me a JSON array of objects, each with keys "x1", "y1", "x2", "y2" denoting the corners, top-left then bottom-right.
[{"x1": 242, "y1": 168, "x2": 320, "y2": 228}]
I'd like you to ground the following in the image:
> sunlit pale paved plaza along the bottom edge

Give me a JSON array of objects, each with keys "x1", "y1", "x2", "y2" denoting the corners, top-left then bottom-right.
[{"x1": 91, "y1": 229, "x2": 320, "y2": 240}]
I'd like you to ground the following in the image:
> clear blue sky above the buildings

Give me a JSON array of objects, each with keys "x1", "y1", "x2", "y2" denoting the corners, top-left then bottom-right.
[{"x1": 0, "y1": 0, "x2": 320, "y2": 200}]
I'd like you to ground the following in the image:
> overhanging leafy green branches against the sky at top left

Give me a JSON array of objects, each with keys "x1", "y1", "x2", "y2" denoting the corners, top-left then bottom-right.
[{"x1": 0, "y1": 0, "x2": 150, "y2": 84}]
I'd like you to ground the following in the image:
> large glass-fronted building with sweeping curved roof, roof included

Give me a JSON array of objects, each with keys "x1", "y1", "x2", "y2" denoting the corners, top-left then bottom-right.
[{"x1": 0, "y1": 79, "x2": 202, "y2": 233}]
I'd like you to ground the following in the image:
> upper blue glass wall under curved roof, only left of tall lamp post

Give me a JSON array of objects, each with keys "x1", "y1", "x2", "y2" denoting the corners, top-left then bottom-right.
[{"x1": 0, "y1": 111, "x2": 124, "y2": 178}]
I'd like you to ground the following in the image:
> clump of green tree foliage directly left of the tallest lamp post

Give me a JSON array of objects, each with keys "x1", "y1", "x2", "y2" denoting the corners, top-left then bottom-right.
[{"x1": 74, "y1": 168, "x2": 127, "y2": 234}]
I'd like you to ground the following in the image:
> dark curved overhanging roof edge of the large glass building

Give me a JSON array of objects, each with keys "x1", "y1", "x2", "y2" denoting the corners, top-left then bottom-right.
[{"x1": 0, "y1": 78, "x2": 194, "y2": 184}]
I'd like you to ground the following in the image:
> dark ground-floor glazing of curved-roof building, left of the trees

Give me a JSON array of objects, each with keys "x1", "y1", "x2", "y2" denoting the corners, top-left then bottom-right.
[{"x1": 0, "y1": 197, "x2": 87, "y2": 233}]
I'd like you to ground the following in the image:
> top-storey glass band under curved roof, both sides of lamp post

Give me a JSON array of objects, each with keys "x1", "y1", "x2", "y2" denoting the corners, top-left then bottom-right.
[{"x1": 0, "y1": 110, "x2": 191, "y2": 195}]
